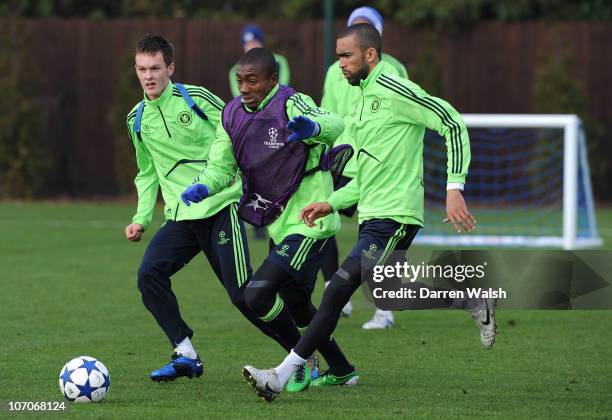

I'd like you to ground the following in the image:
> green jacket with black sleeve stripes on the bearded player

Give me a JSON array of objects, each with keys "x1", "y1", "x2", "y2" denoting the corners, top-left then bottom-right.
[{"x1": 327, "y1": 61, "x2": 470, "y2": 226}]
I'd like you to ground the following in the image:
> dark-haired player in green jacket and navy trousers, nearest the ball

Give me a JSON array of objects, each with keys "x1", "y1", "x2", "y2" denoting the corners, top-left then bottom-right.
[{"x1": 125, "y1": 35, "x2": 290, "y2": 381}]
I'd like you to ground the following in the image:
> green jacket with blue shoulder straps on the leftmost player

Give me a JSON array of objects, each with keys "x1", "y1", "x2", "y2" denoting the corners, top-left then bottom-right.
[{"x1": 127, "y1": 82, "x2": 242, "y2": 230}]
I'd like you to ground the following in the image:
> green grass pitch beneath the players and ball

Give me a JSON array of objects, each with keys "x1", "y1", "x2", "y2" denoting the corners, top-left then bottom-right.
[{"x1": 0, "y1": 203, "x2": 612, "y2": 419}]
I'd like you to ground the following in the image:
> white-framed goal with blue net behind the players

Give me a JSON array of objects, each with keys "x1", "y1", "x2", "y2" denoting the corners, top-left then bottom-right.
[{"x1": 415, "y1": 114, "x2": 603, "y2": 249}]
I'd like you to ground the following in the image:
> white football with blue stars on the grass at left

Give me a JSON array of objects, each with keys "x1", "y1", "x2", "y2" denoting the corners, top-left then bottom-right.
[{"x1": 59, "y1": 356, "x2": 110, "y2": 403}]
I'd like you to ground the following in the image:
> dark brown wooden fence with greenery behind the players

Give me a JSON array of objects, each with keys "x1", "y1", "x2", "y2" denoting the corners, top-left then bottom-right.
[{"x1": 0, "y1": 0, "x2": 612, "y2": 201}]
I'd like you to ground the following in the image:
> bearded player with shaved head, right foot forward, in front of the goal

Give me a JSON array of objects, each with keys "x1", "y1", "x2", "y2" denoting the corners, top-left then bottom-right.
[{"x1": 243, "y1": 24, "x2": 496, "y2": 400}]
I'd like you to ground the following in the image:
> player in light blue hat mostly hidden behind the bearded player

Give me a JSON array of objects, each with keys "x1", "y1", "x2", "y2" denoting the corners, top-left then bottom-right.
[{"x1": 321, "y1": 7, "x2": 408, "y2": 330}]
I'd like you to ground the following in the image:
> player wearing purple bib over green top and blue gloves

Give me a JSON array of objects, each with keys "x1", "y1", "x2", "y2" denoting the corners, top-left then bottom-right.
[{"x1": 182, "y1": 48, "x2": 358, "y2": 398}]
